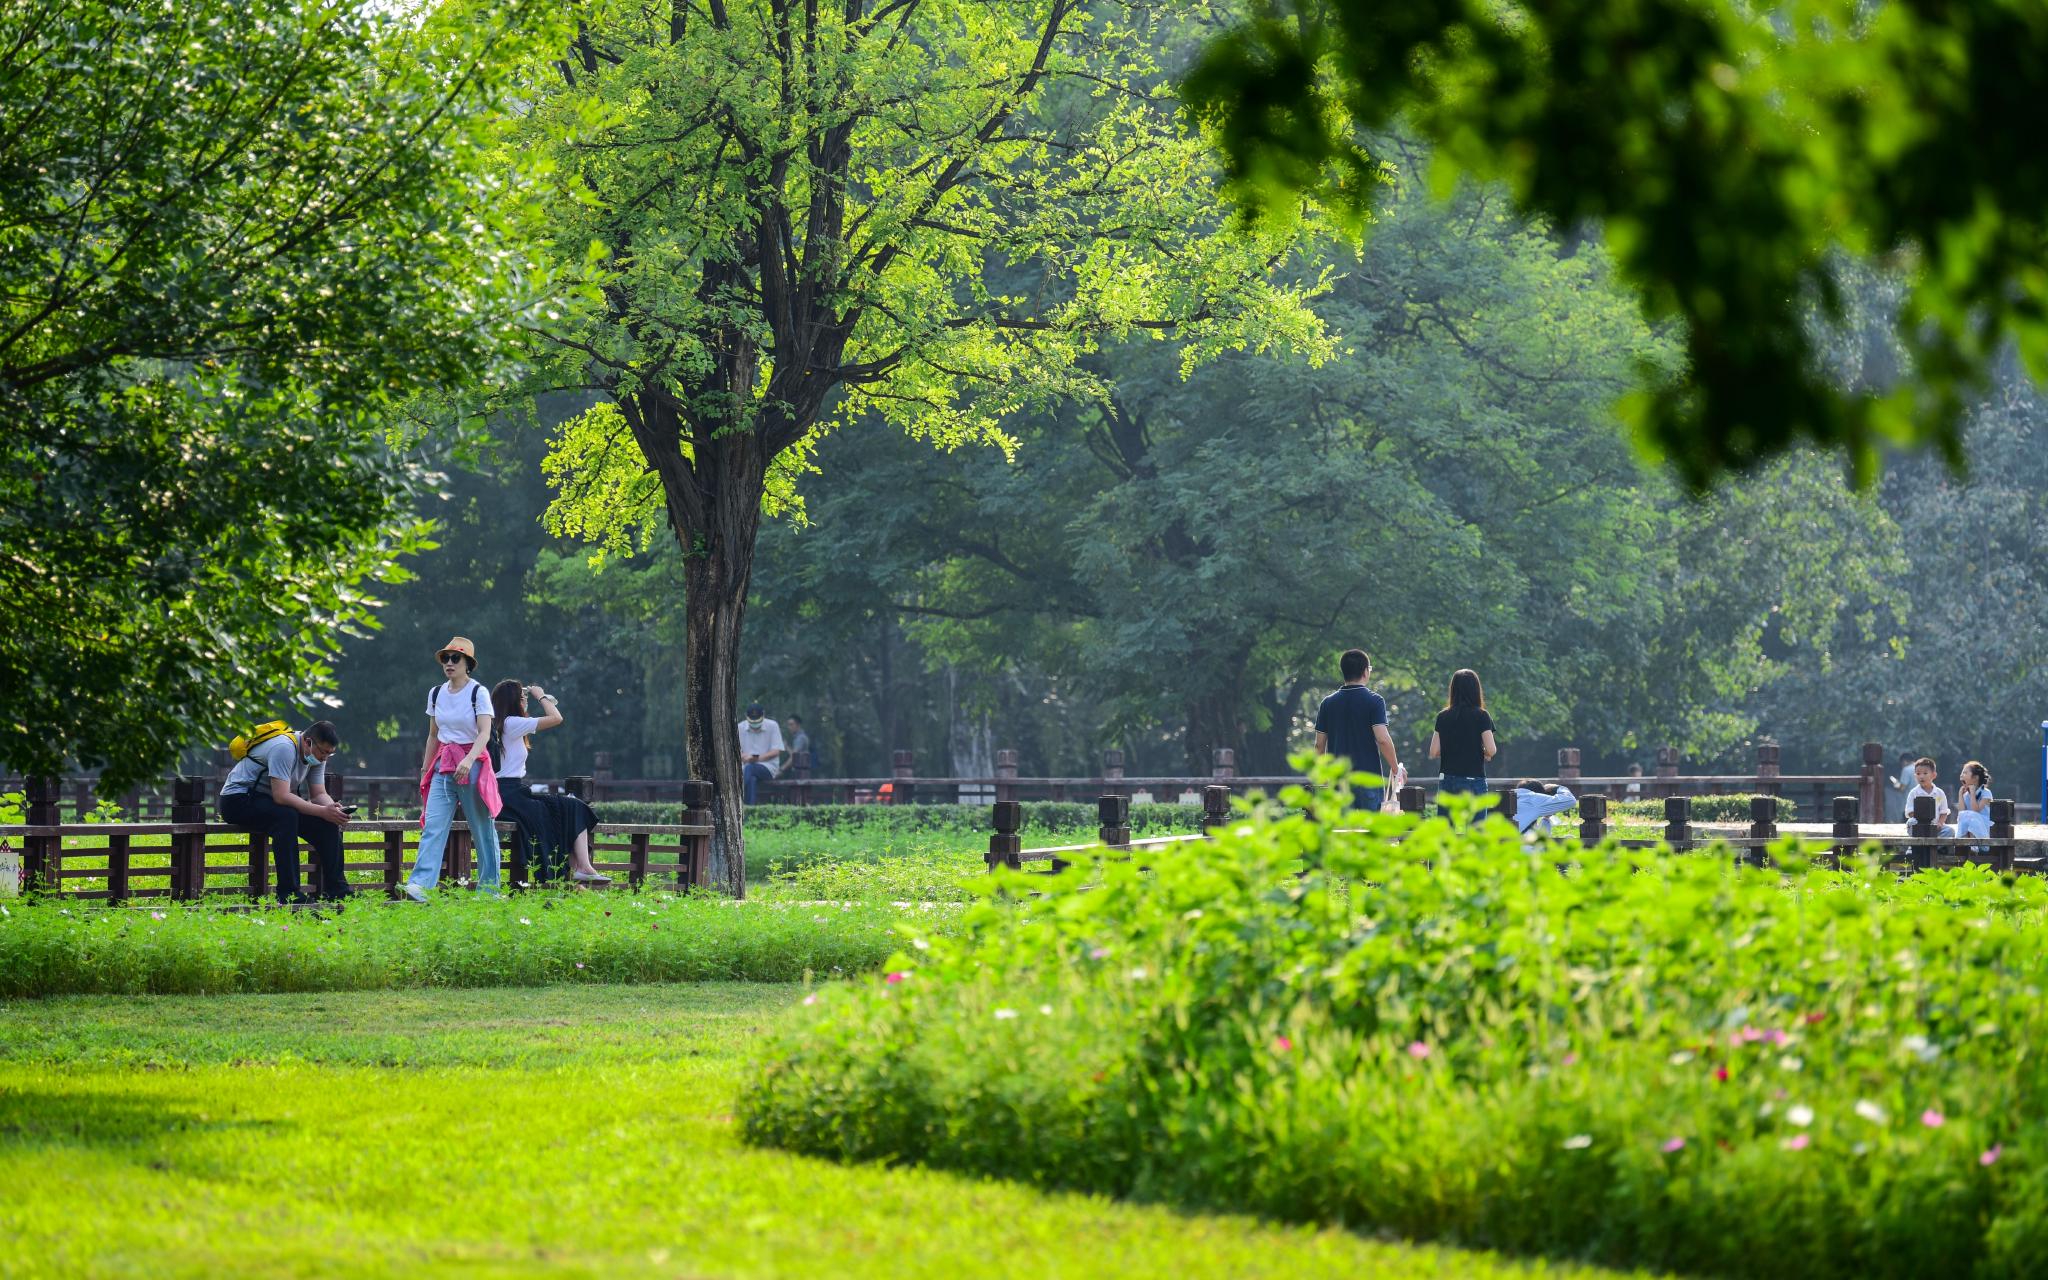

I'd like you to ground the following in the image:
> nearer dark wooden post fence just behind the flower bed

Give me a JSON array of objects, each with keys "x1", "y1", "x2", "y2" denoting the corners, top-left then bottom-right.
[{"x1": 985, "y1": 786, "x2": 2048, "y2": 874}]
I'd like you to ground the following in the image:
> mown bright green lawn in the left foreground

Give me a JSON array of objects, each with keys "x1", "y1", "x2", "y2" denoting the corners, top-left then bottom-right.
[{"x1": 0, "y1": 985, "x2": 1646, "y2": 1280}]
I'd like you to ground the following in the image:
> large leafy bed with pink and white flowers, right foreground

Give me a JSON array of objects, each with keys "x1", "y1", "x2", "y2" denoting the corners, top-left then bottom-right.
[{"x1": 739, "y1": 757, "x2": 2048, "y2": 1278}]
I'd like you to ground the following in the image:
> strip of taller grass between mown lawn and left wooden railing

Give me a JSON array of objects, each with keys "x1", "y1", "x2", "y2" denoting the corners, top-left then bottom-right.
[{"x1": 0, "y1": 893, "x2": 958, "y2": 997}]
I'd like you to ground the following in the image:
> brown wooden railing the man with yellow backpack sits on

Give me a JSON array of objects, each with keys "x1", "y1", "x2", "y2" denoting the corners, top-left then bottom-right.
[{"x1": 0, "y1": 778, "x2": 711, "y2": 903}]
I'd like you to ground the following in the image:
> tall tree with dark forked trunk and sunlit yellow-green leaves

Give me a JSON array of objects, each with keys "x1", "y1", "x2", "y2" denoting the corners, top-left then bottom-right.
[{"x1": 512, "y1": 0, "x2": 1319, "y2": 893}]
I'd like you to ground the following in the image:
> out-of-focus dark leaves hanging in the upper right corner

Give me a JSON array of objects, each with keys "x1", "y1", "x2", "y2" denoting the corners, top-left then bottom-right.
[{"x1": 1188, "y1": 0, "x2": 2048, "y2": 485}]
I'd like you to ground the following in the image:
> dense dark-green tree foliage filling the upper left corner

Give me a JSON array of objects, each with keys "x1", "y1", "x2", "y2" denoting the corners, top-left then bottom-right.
[{"x1": 0, "y1": 0, "x2": 552, "y2": 786}]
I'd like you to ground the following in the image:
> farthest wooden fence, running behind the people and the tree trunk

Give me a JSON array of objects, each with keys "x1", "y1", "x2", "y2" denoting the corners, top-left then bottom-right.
[{"x1": 0, "y1": 741, "x2": 1916, "y2": 823}]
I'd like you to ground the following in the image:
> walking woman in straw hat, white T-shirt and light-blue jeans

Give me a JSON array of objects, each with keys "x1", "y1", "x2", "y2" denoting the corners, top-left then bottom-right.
[{"x1": 406, "y1": 635, "x2": 500, "y2": 903}]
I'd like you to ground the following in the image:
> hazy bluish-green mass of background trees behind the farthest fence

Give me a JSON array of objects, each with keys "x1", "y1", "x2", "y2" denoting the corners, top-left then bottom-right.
[{"x1": 323, "y1": 139, "x2": 2048, "y2": 795}]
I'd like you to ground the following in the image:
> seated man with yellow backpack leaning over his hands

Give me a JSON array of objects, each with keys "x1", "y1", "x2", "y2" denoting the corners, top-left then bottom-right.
[{"x1": 221, "y1": 721, "x2": 348, "y2": 903}]
